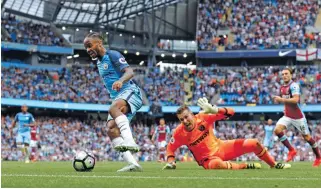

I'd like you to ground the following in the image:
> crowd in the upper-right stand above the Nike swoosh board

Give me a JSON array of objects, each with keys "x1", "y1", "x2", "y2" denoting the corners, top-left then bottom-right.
[{"x1": 197, "y1": 0, "x2": 321, "y2": 50}]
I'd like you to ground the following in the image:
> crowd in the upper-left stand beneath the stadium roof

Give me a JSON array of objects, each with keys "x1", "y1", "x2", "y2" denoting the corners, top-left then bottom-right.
[{"x1": 1, "y1": 14, "x2": 64, "y2": 46}]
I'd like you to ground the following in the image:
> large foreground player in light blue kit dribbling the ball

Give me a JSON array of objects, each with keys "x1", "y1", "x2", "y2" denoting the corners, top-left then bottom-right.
[{"x1": 84, "y1": 32, "x2": 143, "y2": 172}]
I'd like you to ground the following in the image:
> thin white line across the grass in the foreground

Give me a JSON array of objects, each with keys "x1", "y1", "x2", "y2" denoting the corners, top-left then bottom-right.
[{"x1": 1, "y1": 174, "x2": 321, "y2": 181}]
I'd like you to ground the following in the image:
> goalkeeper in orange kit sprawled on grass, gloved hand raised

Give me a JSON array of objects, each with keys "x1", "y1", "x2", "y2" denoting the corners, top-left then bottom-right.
[{"x1": 163, "y1": 98, "x2": 291, "y2": 169}]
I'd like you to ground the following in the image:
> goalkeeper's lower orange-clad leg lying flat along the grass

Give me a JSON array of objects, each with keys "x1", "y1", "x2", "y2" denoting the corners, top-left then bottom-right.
[{"x1": 203, "y1": 157, "x2": 249, "y2": 170}]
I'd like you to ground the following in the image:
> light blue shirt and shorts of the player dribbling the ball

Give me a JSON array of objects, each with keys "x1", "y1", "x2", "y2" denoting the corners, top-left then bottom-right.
[{"x1": 97, "y1": 50, "x2": 143, "y2": 121}]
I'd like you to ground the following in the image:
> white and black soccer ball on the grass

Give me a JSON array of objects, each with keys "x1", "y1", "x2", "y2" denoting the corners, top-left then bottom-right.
[{"x1": 72, "y1": 151, "x2": 96, "y2": 172}]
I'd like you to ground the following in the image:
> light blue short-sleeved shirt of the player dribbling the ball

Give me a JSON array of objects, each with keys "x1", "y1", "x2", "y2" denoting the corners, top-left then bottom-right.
[{"x1": 97, "y1": 50, "x2": 139, "y2": 99}]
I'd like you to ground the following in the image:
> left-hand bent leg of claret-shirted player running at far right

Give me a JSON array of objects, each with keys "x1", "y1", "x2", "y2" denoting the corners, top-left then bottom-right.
[{"x1": 274, "y1": 116, "x2": 296, "y2": 162}]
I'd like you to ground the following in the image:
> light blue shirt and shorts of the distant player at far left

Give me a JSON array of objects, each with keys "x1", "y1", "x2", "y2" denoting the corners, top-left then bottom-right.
[{"x1": 14, "y1": 112, "x2": 35, "y2": 144}]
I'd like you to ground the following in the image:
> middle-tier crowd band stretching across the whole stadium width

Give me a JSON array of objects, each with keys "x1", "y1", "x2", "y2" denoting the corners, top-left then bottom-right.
[{"x1": 1, "y1": 65, "x2": 321, "y2": 105}]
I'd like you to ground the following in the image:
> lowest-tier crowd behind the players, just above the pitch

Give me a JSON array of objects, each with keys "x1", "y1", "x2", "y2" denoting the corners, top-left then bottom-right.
[{"x1": 1, "y1": 116, "x2": 321, "y2": 161}]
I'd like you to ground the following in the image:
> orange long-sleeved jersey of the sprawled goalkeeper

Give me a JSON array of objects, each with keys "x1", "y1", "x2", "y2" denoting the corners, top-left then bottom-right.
[{"x1": 166, "y1": 111, "x2": 234, "y2": 165}]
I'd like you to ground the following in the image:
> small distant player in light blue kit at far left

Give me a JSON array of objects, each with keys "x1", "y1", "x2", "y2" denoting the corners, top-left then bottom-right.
[{"x1": 10, "y1": 105, "x2": 35, "y2": 163}]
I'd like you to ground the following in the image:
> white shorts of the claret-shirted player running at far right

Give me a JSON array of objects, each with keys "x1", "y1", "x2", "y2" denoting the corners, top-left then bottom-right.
[{"x1": 276, "y1": 116, "x2": 310, "y2": 135}]
